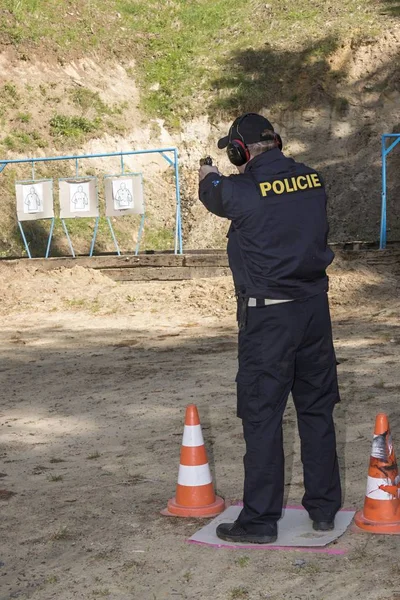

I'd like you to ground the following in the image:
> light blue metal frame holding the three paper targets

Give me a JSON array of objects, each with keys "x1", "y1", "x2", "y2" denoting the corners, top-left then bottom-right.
[{"x1": 0, "y1": 148, "x2": 183, "y2": 258}]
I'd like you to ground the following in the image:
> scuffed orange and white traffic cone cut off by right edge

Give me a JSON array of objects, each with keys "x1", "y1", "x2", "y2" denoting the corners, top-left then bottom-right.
[{"x1": 354, "y1": 413, "x2": 400, "y2": 534}]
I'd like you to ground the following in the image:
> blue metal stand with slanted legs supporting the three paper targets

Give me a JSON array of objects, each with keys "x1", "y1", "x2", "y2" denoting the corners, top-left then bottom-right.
[{"x1": 0, "y1": 148, "x2": 183, "y2": 258}]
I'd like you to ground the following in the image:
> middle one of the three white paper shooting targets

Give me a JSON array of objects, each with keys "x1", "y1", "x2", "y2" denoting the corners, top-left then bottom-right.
[{"x1": 59, "y1": 177, "x2": 99, "y2": 219}]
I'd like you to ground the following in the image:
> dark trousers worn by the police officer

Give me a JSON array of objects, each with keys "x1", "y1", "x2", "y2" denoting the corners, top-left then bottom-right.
[{"x1": 236, "y1": 293, "x2": 341, "y2": 535}]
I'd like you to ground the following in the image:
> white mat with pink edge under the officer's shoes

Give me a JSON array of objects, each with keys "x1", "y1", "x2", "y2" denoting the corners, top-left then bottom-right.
[{"x1": 188, "y1": 506, "x2": 355, "y2": 554}]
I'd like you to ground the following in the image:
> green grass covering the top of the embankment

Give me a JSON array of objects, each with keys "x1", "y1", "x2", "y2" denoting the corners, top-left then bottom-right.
[{"x1": 0, "y1": 0, "x2": 398, "y2": 126}]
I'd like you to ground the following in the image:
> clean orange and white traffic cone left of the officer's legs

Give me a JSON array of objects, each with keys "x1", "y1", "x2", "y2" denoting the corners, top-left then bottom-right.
[{"x1": 161, "y1": 404, "x2": 225, "y2": 517}]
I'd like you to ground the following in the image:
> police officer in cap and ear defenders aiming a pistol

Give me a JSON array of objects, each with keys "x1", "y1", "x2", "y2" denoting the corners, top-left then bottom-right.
[{"x1": 199, "y1": 113, "x2": 341, "y2": 544}]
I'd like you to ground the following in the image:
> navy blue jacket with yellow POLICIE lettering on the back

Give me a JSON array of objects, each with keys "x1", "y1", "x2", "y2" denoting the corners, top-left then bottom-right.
[{"x1": 199, "y1": 148, "x2": 334, "y2": 299}]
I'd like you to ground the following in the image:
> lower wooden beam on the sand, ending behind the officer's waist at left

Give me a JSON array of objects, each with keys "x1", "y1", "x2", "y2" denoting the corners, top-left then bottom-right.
[{"x1": 101, "y1": 267, "x2": 230, "y2": 281}]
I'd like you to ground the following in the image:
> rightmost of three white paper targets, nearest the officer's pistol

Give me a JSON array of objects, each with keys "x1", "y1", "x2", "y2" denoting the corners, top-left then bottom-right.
[{"x1": 105, "y1": 173, "x2": 144, "y2": 217}]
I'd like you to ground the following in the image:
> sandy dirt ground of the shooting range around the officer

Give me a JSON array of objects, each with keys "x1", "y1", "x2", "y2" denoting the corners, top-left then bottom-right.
[{"x1": 0, "y1": 261, "x2": 400, "y2": 600}]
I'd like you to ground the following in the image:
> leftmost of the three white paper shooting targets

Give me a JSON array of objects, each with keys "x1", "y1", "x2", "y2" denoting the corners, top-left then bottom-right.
[{"x1": 15, "y1": 179, "x2": 54, "y2": 221}]
